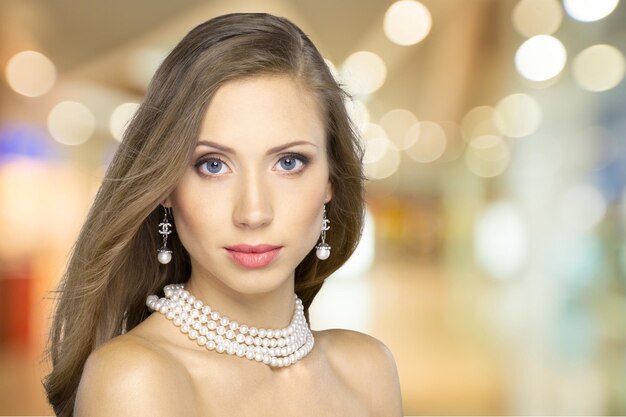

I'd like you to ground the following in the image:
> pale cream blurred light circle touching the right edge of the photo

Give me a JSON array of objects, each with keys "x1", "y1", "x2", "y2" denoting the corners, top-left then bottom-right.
[{"x1": 572, "y1": 45, "x2": 626, "y2": 91}]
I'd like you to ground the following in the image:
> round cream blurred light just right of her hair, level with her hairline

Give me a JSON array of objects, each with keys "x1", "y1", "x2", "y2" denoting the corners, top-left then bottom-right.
[{"x1": 341, "y1": 51, "x2": 387, "y2": 95}]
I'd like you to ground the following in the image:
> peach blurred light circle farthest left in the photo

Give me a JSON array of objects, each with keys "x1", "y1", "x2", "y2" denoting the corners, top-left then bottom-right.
[{"x1": 5, "y1": 51, "x2": 56, "y2": 97}]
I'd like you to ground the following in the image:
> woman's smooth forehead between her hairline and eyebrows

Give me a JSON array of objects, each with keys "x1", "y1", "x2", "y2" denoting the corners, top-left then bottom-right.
[{"x1": 198, "y1": 76, "x2": 326, "y2": 151}]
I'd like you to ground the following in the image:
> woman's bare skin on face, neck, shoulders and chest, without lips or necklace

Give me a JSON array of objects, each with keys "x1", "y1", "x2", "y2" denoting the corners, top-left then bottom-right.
[{"x1": 74, "y1": 76, "x2": 402, "y2": 417}]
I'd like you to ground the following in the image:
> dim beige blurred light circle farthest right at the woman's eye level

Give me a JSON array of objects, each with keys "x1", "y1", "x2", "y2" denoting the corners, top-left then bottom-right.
[{"x1": 465, "y1": 135, "x2": 511, "y2": 178}]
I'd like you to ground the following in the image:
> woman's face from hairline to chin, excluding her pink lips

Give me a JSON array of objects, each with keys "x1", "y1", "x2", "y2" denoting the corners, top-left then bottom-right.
[{"x1": 165, "y1": 76, "x2": 331, "y2": 294}]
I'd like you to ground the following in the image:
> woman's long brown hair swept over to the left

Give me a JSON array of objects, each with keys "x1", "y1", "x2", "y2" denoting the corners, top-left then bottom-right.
[{"x1": 43, "y1": 13, "x2": 365, "y2": 416}]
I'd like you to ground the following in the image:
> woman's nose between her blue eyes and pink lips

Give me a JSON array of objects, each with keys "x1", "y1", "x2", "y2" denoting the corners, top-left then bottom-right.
[{"x1": 233, "y1": 173, "x2": 273, "y2": 229}]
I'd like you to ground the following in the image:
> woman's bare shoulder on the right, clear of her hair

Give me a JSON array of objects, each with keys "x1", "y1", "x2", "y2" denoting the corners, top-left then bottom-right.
[{"x1": 319, "y1": 329, "x2": 403, "y2": 416}]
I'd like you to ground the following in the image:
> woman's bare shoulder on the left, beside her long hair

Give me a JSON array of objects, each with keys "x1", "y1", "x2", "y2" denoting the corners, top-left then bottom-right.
[{"x1": 74, "y1": 334, "x2": 197, "y2": 417}]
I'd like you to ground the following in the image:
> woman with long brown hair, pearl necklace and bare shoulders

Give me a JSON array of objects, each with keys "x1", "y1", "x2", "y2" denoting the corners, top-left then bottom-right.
[{"x1": 45, "y1": 13, "x2": 402, "y2": 417}]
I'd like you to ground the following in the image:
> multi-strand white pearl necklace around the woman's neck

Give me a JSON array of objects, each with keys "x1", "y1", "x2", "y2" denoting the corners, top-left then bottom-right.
[{"x1": 146, "y1": 284, "x2": 315, "y2": 367}]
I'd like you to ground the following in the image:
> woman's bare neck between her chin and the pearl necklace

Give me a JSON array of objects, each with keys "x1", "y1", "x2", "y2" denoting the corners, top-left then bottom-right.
[{"x1": 185, "y1": 272, "x2": 294, "y2": 329}]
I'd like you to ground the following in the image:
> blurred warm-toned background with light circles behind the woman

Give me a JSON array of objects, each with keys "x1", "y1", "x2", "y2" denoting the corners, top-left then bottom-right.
[{"x1": 0, "y1": 0, "x2": 626, "y2": 415}]
